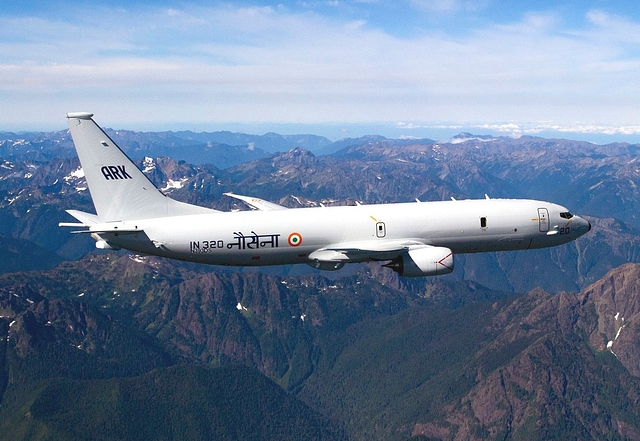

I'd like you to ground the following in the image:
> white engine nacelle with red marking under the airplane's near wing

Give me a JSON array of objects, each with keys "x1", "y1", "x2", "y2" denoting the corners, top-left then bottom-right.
[{"x1": 384, "y1": 246, "x2": 453, "y2": 277}]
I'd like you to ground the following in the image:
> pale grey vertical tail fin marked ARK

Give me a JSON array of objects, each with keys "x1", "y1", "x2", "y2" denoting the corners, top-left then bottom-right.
[{"x1": 67, "y1": 113, "x2": 215, "y2": 222}]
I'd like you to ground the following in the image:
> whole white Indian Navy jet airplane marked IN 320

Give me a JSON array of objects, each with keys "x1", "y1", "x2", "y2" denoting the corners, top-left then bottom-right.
[{"x1": 60, "y1": 112, "x2": 591, "y2": 277}]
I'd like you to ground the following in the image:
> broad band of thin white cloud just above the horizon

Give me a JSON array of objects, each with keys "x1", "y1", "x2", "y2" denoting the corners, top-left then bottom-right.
[{"x1": 0, "y1": 0, "x2": 640, "y2": 130}]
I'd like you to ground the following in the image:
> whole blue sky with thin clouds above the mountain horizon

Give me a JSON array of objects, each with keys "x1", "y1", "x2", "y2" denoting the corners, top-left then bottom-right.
[{"x1": 0, "y1": 0, "x2": 640, "y2": 141}]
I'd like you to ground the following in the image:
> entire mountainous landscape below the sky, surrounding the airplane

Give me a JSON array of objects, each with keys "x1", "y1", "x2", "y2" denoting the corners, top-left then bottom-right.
[{"x1": 0, "y1": 126, "x2": 640, "y2": 440}]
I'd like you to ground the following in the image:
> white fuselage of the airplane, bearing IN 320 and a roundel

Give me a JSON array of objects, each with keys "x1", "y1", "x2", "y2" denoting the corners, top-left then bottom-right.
[{"x1": 104, "y1": 199, "x2": 588, "y2": 265}]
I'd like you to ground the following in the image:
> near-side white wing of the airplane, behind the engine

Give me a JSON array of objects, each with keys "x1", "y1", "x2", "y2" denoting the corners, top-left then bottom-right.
[{"x1": 309, "y1": 240, "x2": 425, "y2": 262}]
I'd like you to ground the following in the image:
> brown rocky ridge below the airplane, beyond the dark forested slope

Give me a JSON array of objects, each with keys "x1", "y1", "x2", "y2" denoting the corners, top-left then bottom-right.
[{"x1": 0, "y1": 255, "x2": 640, "y2": 439}]
